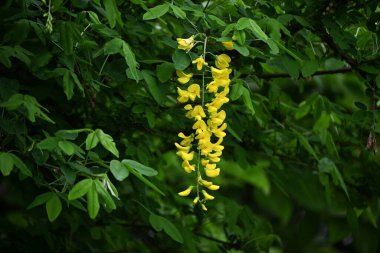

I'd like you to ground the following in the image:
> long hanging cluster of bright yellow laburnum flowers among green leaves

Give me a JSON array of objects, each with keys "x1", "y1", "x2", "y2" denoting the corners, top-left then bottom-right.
[{"x1": 175, "y1": 36, "x2": 232, "y2": 211}]
